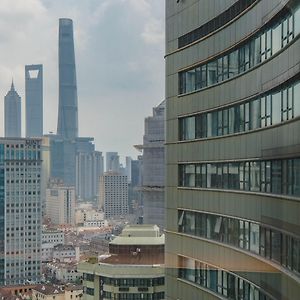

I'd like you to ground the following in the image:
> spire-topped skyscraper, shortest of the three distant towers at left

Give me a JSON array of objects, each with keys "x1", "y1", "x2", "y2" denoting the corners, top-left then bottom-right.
[{"x1": 4, "y1": 82, "x2": 21, "y2": 137}]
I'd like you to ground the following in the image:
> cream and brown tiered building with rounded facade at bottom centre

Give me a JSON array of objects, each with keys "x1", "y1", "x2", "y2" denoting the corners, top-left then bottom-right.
[{"x1": 78, "y1": 225, "x2": 165, "y2": 300}]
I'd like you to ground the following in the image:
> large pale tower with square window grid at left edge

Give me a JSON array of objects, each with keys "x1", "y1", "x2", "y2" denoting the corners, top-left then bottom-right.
[{"x1": 0, "y1": 138, "x2": 42, "y2": 285}]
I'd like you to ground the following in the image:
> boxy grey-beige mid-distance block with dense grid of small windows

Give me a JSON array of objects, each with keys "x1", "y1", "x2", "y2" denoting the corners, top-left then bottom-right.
[{"x1": 99, "y1": 172, "x2": 128, "y2": 219}]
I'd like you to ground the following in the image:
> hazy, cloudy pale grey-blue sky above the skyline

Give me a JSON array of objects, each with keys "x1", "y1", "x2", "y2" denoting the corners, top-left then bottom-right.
[{"x1": 0, "y1": 0, "x2": 165, "y2": 163}]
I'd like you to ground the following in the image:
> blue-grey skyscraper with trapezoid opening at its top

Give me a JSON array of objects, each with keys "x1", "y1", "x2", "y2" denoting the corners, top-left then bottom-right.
[{"x1": 25, "y1": 65, "x2": 43, "y2": 137}]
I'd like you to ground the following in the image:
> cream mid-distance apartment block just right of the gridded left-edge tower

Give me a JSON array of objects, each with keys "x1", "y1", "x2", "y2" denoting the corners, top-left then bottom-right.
[{"x1": 46, "y1": 180, "x2": 75, "y2": 225}]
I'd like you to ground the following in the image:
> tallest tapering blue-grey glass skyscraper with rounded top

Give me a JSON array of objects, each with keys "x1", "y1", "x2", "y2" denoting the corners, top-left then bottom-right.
[{"x1": 57, "y1": 19, "x2": 78, "y2": 140}]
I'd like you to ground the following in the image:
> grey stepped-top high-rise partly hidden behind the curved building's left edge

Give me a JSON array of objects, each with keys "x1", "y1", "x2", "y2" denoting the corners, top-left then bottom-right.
[{"x1": 136, "y1": 101, "x2": 165, "y2": 228}]
